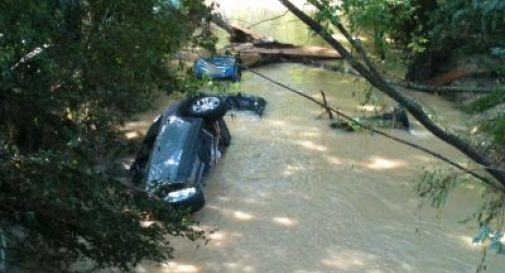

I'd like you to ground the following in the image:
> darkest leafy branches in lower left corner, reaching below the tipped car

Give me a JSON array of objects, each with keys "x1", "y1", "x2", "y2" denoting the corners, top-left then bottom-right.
[{"x1": 0, "y1": 152, "x2": 202, "y2": 272}]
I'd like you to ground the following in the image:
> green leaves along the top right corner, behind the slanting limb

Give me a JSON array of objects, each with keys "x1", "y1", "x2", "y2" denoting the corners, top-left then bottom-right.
[{"x1": 319, "y1": 0, "x2": 505, "y2": 61}]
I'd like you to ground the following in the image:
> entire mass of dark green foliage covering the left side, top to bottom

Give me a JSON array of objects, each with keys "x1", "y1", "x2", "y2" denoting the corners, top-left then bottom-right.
[{"x1": 0, "y1": 0, "x2": 212, "y2": 272}]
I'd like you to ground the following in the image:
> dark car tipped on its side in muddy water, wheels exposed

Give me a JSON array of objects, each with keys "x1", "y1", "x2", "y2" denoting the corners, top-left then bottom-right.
[{"x1": 131, "y1": 95, "x2": 266, "y2": 212}]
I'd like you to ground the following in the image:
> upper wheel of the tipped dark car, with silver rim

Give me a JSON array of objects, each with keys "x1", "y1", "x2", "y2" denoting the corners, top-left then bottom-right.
[{"x1": 182, "y1": 96, "x2": 227, "y2": 122}]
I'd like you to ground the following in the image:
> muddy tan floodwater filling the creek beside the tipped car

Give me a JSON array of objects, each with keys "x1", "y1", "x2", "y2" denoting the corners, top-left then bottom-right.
[{"x1": 137, "y1": 2, "x2": 505, "y2": 273}]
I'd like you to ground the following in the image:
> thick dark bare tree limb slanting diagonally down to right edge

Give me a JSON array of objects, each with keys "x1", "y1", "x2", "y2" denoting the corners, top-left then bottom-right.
[{"x1": 279, "y1": 0, "x2": 505, "y2": 186}]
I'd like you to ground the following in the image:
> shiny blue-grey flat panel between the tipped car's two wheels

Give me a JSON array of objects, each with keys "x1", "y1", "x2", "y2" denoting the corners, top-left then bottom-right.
[{"x1": 146, "y1": 116, "x2": 191, "y2": 190}]
